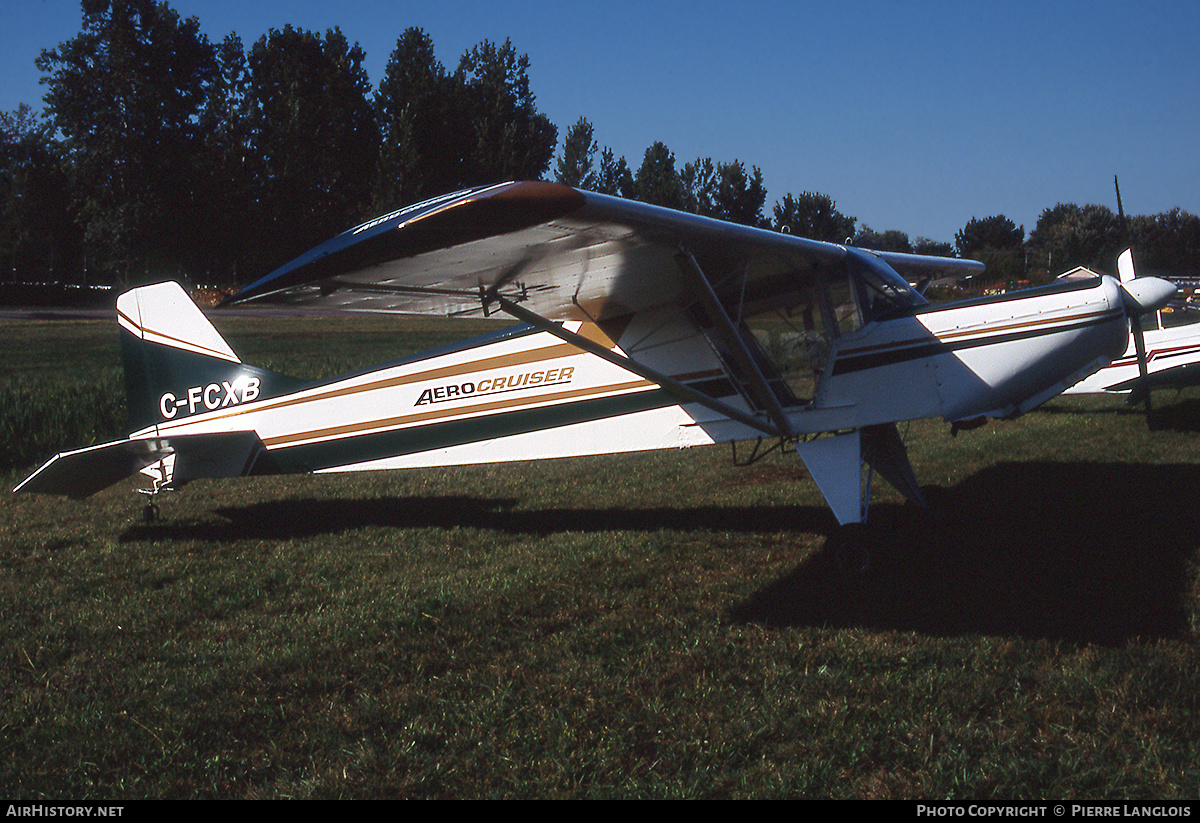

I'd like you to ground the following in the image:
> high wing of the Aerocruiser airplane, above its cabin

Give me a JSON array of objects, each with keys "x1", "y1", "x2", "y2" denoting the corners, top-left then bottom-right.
[{"x1": 229, "y1": 182, "x2": 983, "y2": 323}]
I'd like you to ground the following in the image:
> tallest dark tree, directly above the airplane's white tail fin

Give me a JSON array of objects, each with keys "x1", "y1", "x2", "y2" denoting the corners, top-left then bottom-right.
[{"x1": 37, "y1": 0, "x2": 217, "y2": 281}]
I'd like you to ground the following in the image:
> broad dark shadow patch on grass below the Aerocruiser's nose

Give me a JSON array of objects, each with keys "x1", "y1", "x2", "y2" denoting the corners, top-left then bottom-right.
[{"x1": 734, "y1": 463, "x2": 1200, "y2": 644}]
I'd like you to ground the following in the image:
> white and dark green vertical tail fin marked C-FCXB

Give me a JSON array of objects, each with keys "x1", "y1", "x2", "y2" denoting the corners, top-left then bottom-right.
[{"x1": 116, "y1": 282, "x2": 304, "y2": 431}]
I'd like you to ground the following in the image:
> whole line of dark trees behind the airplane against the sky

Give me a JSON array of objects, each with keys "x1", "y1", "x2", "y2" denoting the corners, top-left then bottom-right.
[{"x1": 0, "y1": 0, "x2": 1200, "y2": 293}]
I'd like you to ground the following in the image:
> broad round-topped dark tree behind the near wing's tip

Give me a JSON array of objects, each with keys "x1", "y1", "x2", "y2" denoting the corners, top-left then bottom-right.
[{"x1": 248, "y1": 25, "x2": 379, "y2": 266}]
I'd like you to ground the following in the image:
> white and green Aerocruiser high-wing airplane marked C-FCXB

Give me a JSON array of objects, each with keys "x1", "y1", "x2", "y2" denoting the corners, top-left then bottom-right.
[{"x1": 16, "y1": 182, "x2": 1175, "y2": 537}]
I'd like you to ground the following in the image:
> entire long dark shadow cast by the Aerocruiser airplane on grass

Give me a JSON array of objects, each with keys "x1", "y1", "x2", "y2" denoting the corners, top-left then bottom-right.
[{"x1": 122, "y1": 463, "x2": 1200, "y2": 643}]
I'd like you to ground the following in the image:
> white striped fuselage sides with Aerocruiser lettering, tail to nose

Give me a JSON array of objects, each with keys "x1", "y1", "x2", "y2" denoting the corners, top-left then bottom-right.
[{"x1": 110, "y1": 280, "x2": 1127, "y2": 477}]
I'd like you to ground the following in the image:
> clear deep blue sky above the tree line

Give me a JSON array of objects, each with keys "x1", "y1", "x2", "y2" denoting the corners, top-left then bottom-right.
[{"x1": 0, "y1": 0, "x2": 1200, "y2": 242}]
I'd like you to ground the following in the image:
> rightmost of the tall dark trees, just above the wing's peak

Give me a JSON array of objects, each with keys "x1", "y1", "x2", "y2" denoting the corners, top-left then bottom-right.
[{"x1": 455, "y1": 40, "x2": 558, "y2": 185}]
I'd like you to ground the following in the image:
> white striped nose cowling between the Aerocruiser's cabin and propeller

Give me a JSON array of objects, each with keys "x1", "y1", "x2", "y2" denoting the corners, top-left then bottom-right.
[{"x1": 808, "y1": 278, "x2": 1128, "y2": 429}]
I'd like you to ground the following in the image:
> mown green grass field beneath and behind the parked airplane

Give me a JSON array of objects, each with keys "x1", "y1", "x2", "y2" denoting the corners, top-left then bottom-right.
[{"x1": 0, "y1": 318, "x2": 1200, "y2": 801}]
